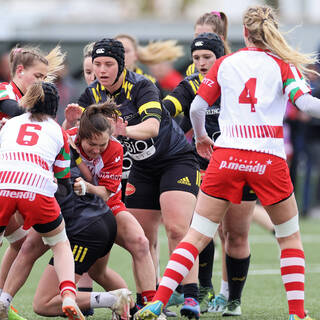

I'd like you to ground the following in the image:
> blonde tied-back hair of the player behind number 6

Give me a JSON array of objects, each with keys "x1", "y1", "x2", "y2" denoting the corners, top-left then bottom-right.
[{"x1": 9, "y1": 45, "x2": 66, "y2": 82}]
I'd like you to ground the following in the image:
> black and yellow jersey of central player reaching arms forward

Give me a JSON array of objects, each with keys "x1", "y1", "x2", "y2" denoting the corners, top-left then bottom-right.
[{"x1": 79, "y1": 70, "x2": 194, "y2": 167}]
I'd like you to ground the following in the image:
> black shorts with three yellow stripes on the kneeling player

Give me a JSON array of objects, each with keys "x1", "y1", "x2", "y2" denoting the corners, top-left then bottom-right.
[{"x1": 49, "y1": 213, "x2": 117, "y2": 275}]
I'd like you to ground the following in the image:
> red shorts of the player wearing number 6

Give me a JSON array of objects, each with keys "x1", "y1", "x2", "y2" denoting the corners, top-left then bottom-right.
[{"x1": 0, "y1": 189, "x2": 61, "y2": 230}]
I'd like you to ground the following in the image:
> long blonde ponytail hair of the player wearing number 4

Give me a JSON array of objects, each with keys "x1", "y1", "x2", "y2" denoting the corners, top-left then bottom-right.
[{"x1": 243, "y1": 6, "x2": 317, "y2": 76}]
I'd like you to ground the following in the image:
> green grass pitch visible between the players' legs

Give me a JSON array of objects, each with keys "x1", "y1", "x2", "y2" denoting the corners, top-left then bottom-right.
[{"x1": 1, "y1": 219, "x2": 320, "y2": 320}]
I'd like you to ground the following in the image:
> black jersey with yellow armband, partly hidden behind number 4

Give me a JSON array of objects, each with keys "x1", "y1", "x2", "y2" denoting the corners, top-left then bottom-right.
[{"x1": 163, "y1": 73, "x2": 220, "y2": 169}]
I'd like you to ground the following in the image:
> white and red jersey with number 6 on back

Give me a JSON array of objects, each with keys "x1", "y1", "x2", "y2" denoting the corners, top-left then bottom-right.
[{"x1": 0, "y1": 113, "x2": 70, "y2": 197}]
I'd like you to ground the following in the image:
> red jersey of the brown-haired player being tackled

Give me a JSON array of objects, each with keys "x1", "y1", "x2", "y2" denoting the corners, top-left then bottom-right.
[{"x1": 67, "y1": 128, "x2": 123, "y2": 199}]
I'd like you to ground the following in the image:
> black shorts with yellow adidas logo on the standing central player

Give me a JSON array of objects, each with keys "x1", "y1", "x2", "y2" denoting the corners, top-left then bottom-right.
[{"x1": 125, "y1": 159, "x2": 201, "y2": 210}]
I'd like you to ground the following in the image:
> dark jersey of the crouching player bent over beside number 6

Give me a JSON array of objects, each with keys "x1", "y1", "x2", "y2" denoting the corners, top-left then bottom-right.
[{"x1": 55, "y1": 154, "x2": 113, "y2": 235}]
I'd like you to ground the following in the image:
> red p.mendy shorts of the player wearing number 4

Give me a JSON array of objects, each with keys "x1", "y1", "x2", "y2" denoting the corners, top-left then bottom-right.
[{"x1": 201, "y1": 148, "x2": 293, "y2": 206}]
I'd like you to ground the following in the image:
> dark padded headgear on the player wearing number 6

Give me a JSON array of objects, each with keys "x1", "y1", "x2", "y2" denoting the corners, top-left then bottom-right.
[{"x1": 30, "y1": 82, "x2": 59, "y2": 117}]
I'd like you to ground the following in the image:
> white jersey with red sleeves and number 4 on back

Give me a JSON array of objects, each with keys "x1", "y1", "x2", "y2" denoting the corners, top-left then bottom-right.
[{"x1": 197, "y1": 47, "x2": 310, "y2": 158}]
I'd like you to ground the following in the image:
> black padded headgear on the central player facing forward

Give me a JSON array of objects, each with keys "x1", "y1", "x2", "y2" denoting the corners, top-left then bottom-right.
[{"x1": 92, "y1": 39, "x2": 124, "y2": 84}]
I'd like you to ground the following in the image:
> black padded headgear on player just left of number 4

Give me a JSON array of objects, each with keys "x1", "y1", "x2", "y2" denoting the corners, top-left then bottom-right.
[{"x1": 191, "y1": 32, "x2": 225, "y2": 59}]
